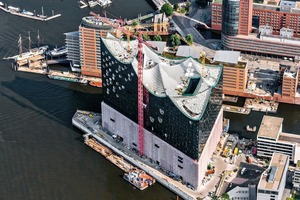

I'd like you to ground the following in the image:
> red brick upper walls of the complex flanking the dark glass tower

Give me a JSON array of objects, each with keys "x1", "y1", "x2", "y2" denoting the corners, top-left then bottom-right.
[{"x1": 211, "y1": 0, "x2": 300, "y2": 36}]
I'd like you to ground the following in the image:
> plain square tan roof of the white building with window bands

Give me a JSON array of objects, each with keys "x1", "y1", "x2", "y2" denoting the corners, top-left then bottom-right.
[{"x1": 257, "y1": 115, "x2": 283, "y2": 139}]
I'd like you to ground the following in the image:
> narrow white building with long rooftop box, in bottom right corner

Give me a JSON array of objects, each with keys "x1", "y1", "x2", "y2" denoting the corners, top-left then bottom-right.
[{"x1": 257, "y1": 153, "x2": 289, "y2": 200}]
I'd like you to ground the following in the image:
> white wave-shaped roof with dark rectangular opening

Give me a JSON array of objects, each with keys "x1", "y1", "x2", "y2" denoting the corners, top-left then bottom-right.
[{"x1": 103, "y1": 35, "x2": 222, "y2": 120}]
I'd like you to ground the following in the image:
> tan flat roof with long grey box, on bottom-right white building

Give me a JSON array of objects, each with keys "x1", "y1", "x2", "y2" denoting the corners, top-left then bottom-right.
[{"x1": 258, "y1": 153, "x2": 288, "y2": 191}]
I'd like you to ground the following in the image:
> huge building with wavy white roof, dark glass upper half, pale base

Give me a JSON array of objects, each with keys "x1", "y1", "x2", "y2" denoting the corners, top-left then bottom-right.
[{"x1": 101, "y1": 35, "x2": 223, "y2": 189}]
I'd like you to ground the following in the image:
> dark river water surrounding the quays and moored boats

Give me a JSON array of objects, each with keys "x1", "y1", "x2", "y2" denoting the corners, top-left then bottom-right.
[{"x1": 0, "y1": 0, "x2": 300, "y2": 200}]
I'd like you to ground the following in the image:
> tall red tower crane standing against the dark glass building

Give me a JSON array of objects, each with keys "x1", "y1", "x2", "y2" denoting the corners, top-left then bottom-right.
[{"x1": 90, "y1": 11, "x2": 155, "y2": 156}]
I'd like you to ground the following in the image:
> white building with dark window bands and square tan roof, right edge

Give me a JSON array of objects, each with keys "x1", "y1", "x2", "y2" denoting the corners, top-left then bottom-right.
[{"x1": 257, "y1": 115, "x2": 300, "y2": 163}]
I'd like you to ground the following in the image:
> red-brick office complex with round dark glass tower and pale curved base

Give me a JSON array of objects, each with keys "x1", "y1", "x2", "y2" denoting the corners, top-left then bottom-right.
[{"x1": 212, "y1": 0, "x2": 300, "y2": 59}]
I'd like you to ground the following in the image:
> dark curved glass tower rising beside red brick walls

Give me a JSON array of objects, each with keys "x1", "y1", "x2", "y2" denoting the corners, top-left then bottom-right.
[{"x1": 222, "y1": 0, "x2": 240, "y2": 36}]
